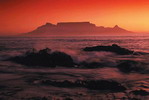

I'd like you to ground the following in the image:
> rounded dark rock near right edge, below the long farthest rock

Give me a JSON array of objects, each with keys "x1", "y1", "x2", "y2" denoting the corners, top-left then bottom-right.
[{"x1": 117, "y1": 60, "x2": 144, "y2": 73}]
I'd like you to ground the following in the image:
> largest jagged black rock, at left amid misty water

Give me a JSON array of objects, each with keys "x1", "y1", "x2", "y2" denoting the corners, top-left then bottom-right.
[{"x1": 8, "y1": 48, "x2": 74, "y2": 67}]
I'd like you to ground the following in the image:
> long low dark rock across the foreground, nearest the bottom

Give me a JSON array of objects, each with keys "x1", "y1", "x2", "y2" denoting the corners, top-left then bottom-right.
[{"x1": 41, "y1": 80, "x2": 126, "y2": 92}]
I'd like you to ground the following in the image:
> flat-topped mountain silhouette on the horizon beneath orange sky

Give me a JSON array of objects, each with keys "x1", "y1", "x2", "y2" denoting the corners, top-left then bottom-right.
[{"x1": 26, "y1": 22, "x2": 133, "y2": 36}]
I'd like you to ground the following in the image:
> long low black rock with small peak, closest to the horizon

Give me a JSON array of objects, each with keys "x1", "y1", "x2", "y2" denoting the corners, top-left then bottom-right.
[{"x1": 83, "y1": 44, "x2": 134, "y2": 55}]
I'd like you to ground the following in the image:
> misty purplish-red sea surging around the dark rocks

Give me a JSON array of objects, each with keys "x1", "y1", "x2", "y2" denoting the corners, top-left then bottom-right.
[{"x1": 0, "y1": 36, "x2": 149, "y2": 100}]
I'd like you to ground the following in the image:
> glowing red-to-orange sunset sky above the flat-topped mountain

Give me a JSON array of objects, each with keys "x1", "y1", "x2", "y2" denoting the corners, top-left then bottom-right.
[{"x1": 0, "y1": 0, "x2": 149, "y2": 34}]
